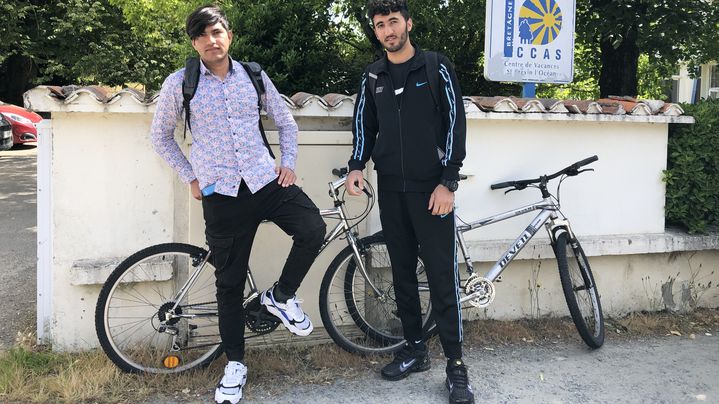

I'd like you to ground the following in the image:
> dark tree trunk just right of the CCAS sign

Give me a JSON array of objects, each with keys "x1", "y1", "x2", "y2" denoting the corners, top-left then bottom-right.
[{"x1": 599, "y1": 26, "x2": 639, "y2": 98}]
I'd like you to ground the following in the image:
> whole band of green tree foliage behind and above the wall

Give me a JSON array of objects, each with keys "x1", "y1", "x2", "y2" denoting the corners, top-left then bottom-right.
[{"x1": 0, "y1": 0, "x2": 719, "y2": 103}]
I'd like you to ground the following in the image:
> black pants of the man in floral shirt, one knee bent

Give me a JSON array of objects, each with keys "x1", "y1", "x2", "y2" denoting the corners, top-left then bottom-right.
[{"x1": 202, "y1": 180, "x2": 325, "y2": 361}]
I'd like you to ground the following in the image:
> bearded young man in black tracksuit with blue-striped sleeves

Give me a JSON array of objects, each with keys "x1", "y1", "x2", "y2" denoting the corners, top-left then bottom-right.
[{"x1": 347, "y1": 0, "x2": 474, "y2": 403}]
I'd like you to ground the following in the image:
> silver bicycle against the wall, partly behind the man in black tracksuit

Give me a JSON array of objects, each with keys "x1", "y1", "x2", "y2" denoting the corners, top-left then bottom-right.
[{"x1": 320, "y1": 156, "x2": 604, "y2": 354}]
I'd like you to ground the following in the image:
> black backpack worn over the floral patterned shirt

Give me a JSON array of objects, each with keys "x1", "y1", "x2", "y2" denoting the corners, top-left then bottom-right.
[{"x1": 182, "y1": 57, "x2": 275, "y2": 159}]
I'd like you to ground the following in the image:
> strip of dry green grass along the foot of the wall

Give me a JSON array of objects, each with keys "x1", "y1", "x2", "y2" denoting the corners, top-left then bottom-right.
[{"x1": 0, "y1": 309, "x2": 719, "y2": 403}]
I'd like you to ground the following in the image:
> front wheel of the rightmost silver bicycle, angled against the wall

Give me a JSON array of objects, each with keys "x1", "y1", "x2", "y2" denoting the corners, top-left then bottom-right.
[{"x1": 554, "y1": 231, "x2": 604, "y2": 348}]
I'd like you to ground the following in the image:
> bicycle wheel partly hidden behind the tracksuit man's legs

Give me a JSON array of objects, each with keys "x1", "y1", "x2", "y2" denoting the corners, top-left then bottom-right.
[{"x1": 320, "y1": 234, "x2": 435, "y2": 354}]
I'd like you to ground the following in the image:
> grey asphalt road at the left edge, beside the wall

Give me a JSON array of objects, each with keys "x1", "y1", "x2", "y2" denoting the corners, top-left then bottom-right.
[{"x1": 0, "y1": 145, "x2": 37, "y2": 350}]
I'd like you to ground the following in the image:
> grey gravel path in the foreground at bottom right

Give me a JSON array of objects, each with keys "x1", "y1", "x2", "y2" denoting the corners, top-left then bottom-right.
[{"x1": 245, "y1": 335, "x2": 719, "y2": 404}]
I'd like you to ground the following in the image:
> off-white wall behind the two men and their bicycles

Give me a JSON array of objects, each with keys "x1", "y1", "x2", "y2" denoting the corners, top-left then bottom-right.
[{"x1": 28, "y1": 89, "x2": 719, "y2": 350}]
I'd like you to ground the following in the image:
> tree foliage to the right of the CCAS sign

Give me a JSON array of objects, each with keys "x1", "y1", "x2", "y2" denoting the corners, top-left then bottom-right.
[{"x1": 577, "y1": 0, "x2": 719, "y2": 97}]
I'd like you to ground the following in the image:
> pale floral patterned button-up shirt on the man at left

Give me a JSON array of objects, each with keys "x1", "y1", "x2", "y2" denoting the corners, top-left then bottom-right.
[{"x1": 151, "y1": 60, "x2": 297, "y2": 196}]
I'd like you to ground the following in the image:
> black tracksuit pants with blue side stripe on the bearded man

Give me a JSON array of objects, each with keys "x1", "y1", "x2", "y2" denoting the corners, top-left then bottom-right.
[{"x1": 379, "y1": 189, "x2": 462, "y2": 359}]
